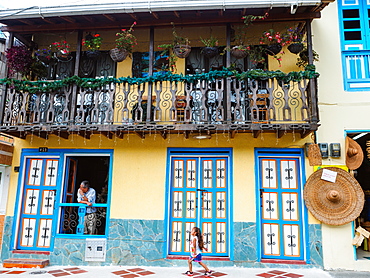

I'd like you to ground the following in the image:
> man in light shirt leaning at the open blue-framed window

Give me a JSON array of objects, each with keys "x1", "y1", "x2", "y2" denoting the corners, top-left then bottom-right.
[{"x1": 77, "y1": 181, "x2": 96, "y2": 235}]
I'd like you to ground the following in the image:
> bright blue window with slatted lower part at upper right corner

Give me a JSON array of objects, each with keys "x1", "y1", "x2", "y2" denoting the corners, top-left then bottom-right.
[{"x1": 338, "y1": 0, "x2": 370, "y2": 91}]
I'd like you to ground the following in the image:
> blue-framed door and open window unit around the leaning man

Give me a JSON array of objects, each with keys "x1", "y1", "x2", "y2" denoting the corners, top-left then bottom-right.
[{"x1": 12, "y1": 149, "x2": 113, "y2": 250}]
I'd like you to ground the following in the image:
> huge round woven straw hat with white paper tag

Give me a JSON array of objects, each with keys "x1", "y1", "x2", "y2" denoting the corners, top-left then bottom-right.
[{"x1": 303, "y1": 167, "x2": 365, "y2": 226}]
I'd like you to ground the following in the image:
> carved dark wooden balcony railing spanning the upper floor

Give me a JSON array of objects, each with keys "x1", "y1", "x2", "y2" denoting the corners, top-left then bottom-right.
[{"x1": 0, "y1": 71, "x2": 318, "y2": 139}]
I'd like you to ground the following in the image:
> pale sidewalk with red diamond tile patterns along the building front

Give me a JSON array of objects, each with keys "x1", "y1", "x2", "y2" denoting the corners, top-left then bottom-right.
[{"x1": 0, "y1": 266, "x2": 336, "y2": 278}]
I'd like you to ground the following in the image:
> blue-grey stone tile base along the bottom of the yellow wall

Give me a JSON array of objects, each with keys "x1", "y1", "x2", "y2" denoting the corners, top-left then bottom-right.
[{"x1": 1, "y1": 217, "x2": 323, "y2": 268}]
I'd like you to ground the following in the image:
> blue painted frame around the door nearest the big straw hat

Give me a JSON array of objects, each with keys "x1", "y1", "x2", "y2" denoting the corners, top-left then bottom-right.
[{"x1": 254, "y1": 148, "x2": 310, "y2": 263}]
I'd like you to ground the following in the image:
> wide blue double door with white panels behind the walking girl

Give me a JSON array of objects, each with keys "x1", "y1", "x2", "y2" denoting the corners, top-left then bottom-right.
[{"x1": 168, "y1": 157, "x2": 230, "y2": 256}]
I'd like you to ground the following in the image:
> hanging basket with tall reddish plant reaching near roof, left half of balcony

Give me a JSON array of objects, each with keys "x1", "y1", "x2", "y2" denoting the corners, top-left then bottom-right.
[{"x1": 109, "y1": 21, "x2": 137, "y2": 62}]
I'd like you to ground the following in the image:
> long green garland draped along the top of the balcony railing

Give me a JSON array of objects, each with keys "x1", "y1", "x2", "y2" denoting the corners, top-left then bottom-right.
[{"x1": 0, "y1": 65, "x2": 319, "y2": 93}]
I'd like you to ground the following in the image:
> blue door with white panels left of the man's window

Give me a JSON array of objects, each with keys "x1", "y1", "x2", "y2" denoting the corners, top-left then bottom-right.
[{"x1": 17, "y1": 158, "x2": 59, "y2": 250}]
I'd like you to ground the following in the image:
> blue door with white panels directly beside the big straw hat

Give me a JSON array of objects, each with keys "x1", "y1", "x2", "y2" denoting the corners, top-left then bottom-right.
[{"x1": 259, "y1": 157, "x2": 304, "y2": 260}]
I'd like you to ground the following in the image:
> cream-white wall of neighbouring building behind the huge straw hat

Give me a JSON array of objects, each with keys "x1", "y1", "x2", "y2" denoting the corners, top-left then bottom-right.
[{"x1": 312, "y1": 2, "x2": 370, "y2": 271}]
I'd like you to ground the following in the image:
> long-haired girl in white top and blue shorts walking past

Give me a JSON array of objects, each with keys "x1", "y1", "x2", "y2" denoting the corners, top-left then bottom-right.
[{"x1": 185, "y1": 227, "x2": 212, "y2": 276}]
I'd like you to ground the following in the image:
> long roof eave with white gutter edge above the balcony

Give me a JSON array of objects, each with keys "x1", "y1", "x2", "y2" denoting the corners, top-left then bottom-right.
[{"x1": 0, "y1": 0, "x2": 334, "y2": 34}]
